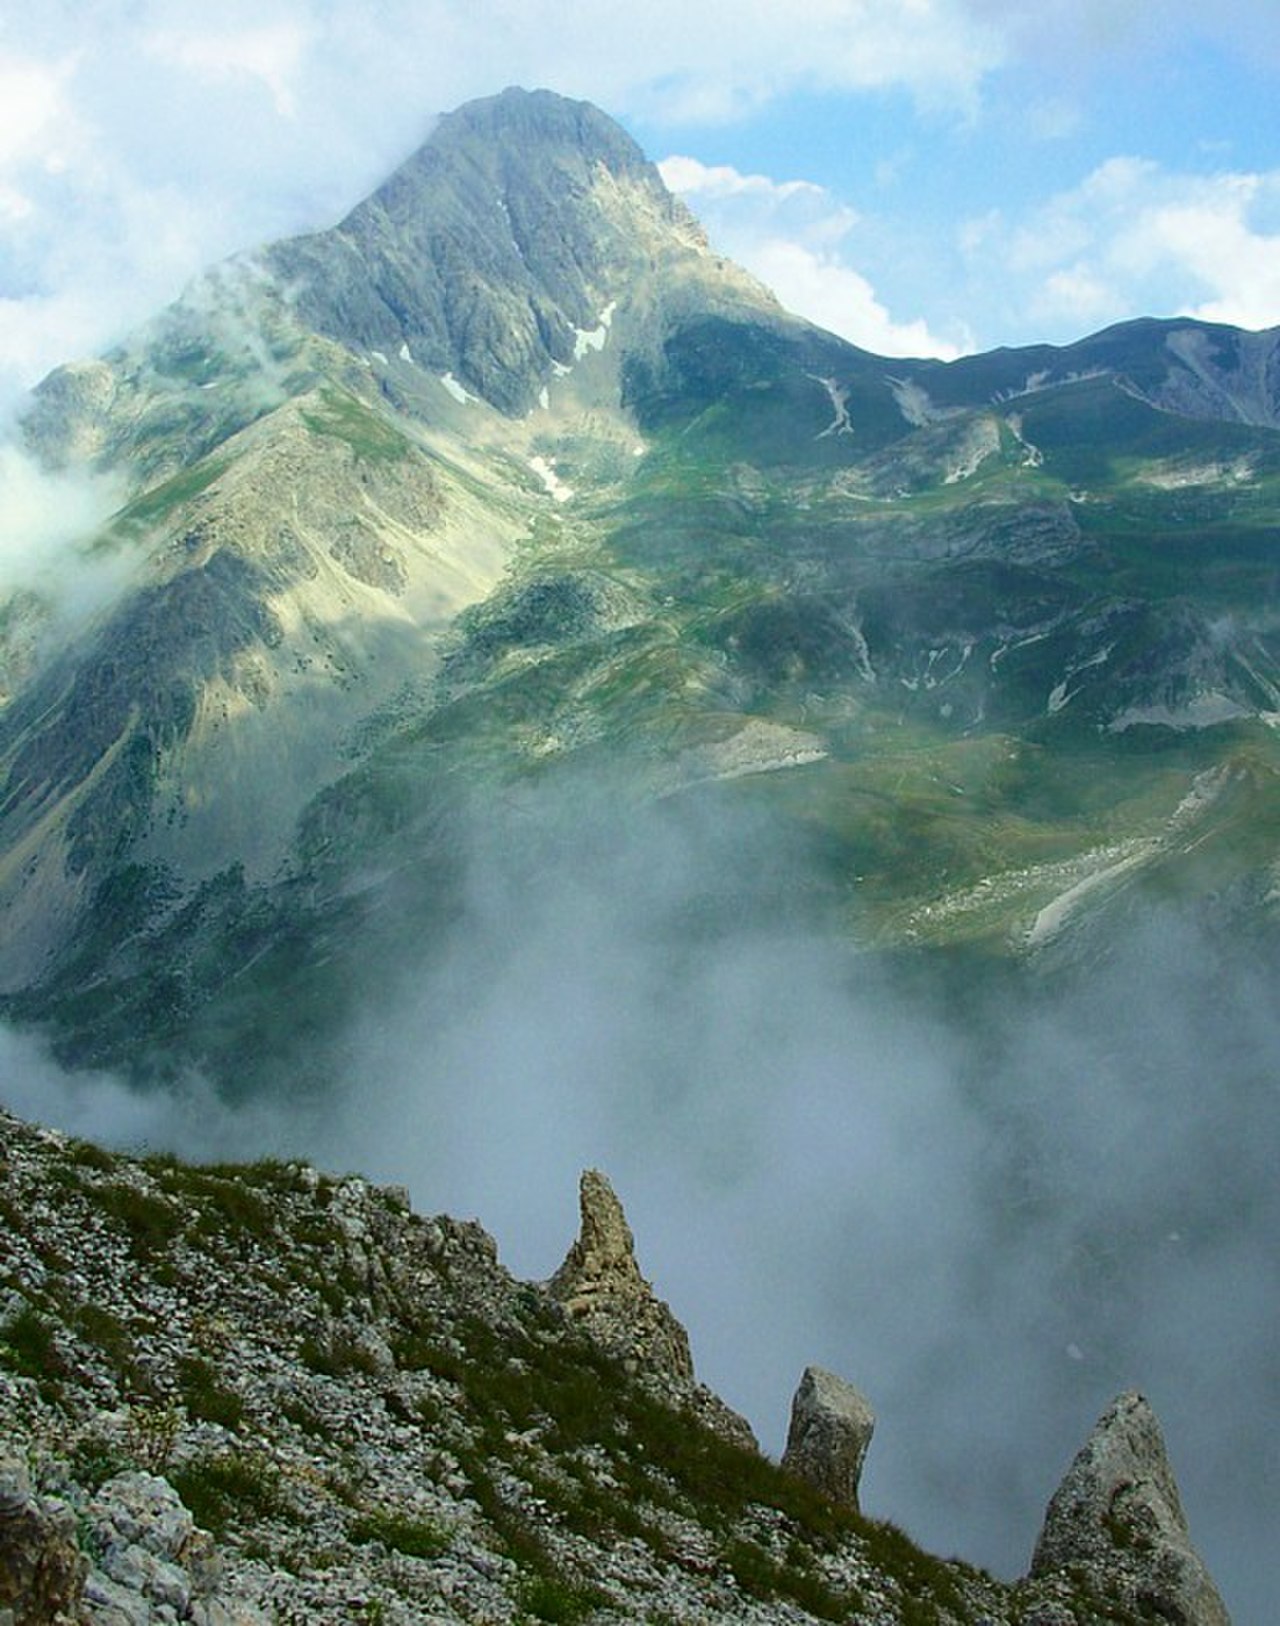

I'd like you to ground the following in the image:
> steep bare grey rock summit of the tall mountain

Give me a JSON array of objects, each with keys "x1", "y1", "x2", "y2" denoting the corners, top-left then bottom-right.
[{"x1": 268, "y1": 89, "x2": 768, "y2": 416}]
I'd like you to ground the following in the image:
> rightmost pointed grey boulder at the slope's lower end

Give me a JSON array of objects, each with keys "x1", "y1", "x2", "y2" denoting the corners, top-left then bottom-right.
[{"x1": 1031, "y1": 1392, "x2": 1230, "y2": 1626}]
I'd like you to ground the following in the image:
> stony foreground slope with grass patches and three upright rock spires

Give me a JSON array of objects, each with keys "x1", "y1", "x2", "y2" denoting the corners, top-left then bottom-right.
[{"x1": 0, "y1": 1115, "x2": 1226, "y2": 1626}]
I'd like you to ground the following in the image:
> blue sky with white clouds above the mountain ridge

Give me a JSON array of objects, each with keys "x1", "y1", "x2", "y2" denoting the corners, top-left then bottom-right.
[{"x1": 0, "y1": 0, "x2": 1280, "y2": 405}]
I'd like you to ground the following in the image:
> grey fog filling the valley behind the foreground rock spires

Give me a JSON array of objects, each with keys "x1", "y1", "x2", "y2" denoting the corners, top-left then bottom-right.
[{"x1": 3, "y1": 780, "x2": 1280, "y2": 1626}]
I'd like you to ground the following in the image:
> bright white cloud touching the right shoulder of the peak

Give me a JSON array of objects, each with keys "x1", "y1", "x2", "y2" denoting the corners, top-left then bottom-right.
[{"x1": 659, "y1": 156, "x2": 966, "y2": 359}]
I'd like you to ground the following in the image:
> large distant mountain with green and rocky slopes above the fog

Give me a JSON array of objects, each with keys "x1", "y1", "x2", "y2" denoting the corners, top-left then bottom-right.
[{"x1": 0, "y1": 91, "x2": 1280, "y2": 1076}]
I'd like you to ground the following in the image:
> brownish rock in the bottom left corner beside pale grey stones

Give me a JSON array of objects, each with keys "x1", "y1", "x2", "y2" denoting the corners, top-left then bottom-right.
[{"x1": 0, "y1": 1455, "x2": 89, "y2": 1626}]
